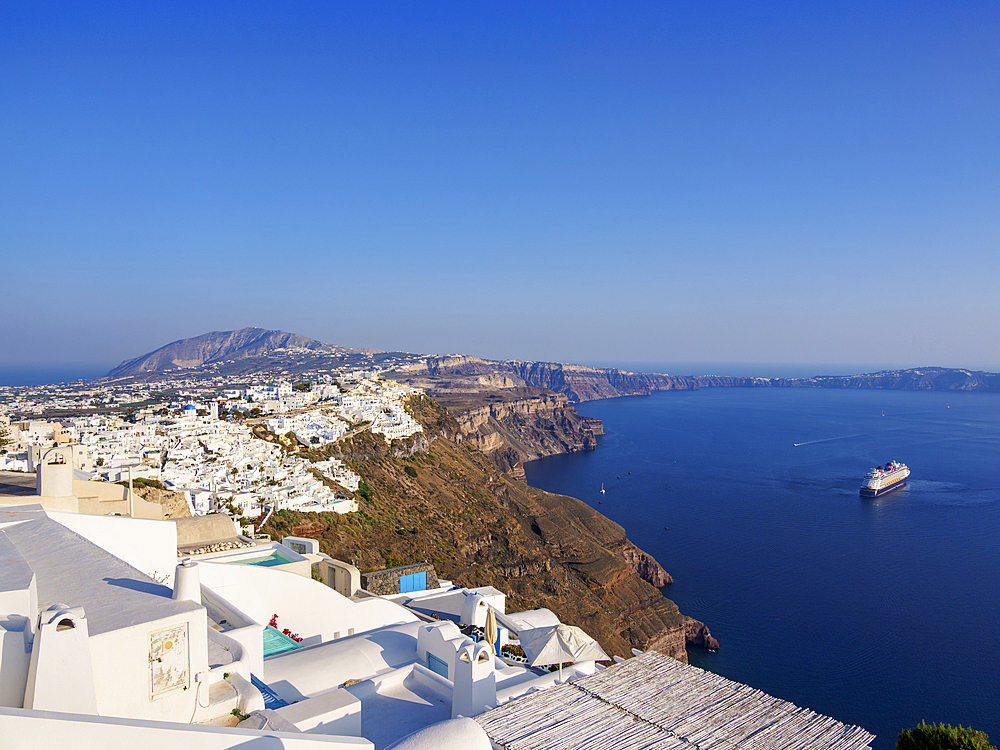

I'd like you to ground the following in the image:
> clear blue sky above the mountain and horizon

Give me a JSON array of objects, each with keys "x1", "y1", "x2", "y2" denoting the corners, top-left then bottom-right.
[{"x1": 0, "y1": 0, "x2": 1000, "y2": 370}]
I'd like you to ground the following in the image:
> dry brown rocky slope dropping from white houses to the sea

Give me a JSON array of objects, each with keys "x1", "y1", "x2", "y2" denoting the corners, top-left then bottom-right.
[{"x1": 267, "y1": 396, "x2": 700, "y2": 661}]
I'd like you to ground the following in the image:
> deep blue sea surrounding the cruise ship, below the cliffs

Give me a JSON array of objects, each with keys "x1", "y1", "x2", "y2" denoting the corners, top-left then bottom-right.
[{"x1": 525, "y1": 388, "x2": 1000, "y2": 750}]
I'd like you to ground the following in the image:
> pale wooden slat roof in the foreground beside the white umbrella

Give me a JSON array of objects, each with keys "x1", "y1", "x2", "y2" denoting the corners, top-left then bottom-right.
[{"x1": 476, "y1": 651, "x2": 874, "y2": 750}]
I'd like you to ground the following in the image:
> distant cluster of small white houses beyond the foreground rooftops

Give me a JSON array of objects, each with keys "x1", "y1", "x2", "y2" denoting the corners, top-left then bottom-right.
[{"x1": 0, "y1": 371, "x2": 422, "y2": 519}]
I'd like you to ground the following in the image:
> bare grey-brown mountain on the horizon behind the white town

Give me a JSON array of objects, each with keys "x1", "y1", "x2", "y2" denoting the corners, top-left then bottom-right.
[{"x1": 108, "y1": 328, "x2": 378, "y2": 378}]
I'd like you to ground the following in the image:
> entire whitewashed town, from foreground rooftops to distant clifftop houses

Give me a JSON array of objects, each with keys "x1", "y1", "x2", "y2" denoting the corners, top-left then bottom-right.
[{"x1": 0, "y1": 360, "x2": 873, "y2": 750}]
